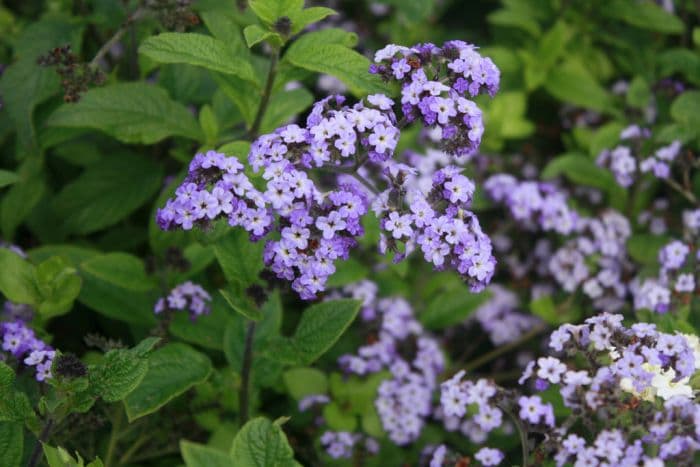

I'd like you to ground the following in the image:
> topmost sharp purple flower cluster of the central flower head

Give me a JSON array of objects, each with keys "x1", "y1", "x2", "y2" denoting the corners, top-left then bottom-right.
[{"x1": 370, "y1": 41, "x2": 500, "y2": 155}]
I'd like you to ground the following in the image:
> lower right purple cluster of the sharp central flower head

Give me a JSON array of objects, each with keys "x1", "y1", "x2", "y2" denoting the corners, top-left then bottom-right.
[{"x1": 372, "y1": 166, "x2": 496, "y2": 292}]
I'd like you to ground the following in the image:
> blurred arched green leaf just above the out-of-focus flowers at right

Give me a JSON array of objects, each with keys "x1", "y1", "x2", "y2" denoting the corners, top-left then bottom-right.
[{"x1": 541, "y1": 153, "x2": 627, "y2": 210}]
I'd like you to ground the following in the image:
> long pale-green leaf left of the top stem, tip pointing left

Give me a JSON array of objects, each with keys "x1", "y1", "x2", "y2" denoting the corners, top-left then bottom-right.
[{"x1": 139, "y1": 32, "x2": 257, "y2": 83}]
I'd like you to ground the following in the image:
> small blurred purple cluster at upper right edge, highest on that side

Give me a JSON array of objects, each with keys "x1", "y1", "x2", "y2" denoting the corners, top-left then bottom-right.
[{"x1": 596, "y1": 125, "x2": 681, "y2": 187}]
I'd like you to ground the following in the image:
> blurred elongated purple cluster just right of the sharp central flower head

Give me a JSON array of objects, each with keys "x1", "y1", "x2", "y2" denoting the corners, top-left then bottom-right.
[{"x1": 484, "y1": 174, "x2": 579, "y2": 235}]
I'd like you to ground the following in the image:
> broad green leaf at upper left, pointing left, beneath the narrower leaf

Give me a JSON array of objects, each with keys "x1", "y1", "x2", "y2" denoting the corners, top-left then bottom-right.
[{"x1": 47, "y1": 82, "x2": 202, "y2": 144}]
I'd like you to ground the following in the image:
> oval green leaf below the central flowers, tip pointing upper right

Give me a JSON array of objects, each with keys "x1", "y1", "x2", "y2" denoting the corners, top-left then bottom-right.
[{"x1": 290, "y1": 299, "x2": 361, "y2": 365}]
